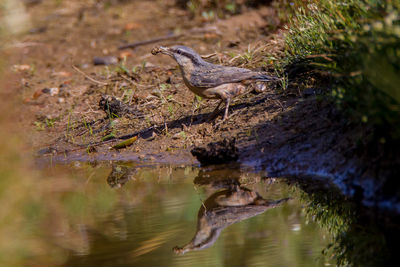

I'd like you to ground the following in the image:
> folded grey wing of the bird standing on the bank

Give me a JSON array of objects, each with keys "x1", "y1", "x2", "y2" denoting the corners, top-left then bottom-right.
[{"x1": 190, "y1": 65, "x2": 273, "y2": 88}]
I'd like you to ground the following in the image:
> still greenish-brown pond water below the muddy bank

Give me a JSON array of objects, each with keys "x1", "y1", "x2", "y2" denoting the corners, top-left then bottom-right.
[{"x1": 38, "y1": 163, "x2": 332, "y2": 266}]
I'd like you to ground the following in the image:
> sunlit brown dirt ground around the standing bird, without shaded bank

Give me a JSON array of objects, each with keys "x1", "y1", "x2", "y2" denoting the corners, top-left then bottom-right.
[{"x1": 12, "y1": 1, "x2": 285, "y2": 161}]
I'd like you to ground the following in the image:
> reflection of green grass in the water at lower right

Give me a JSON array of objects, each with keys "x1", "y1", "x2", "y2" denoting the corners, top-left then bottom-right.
[{"x1": 289, "y1": 180, "x2": 392, "y2": 267}]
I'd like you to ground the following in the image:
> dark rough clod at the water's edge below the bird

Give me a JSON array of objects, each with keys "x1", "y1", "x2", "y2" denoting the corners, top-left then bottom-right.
[{"x1": 190, "y1": 138, "x2": 239, "y2": 166}]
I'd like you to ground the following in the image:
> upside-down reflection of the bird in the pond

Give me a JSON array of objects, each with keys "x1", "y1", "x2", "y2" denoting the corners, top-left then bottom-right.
[{"x1": 174, "y1": 185, "x2": 288, "y2": 254}]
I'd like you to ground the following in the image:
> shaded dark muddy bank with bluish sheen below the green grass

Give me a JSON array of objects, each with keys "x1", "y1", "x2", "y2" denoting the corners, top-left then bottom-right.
[{"x1": 240, "y1": 98, "x2": 400, "y2": 213}]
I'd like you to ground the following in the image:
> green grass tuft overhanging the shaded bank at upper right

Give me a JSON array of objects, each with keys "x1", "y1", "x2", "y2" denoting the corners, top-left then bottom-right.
[{"x1": 281, "y1": 0, "x2": 400, "y2": 143}]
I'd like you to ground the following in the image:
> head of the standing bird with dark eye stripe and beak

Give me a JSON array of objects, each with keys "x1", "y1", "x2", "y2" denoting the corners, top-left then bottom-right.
[{"x1": 151, "y1": 45, "x2": 204, "y2": 67}]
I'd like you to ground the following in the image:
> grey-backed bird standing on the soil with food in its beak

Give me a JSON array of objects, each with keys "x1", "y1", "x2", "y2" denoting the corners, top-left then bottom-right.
[{"x1": 151, "y1": 45, "x2": 277, "y2": 121}]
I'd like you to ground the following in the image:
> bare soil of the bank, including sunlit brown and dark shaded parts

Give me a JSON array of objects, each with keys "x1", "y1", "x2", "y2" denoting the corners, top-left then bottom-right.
[{"x1": 7, "y1": 1, "x2": 400, "y2": 211}]
